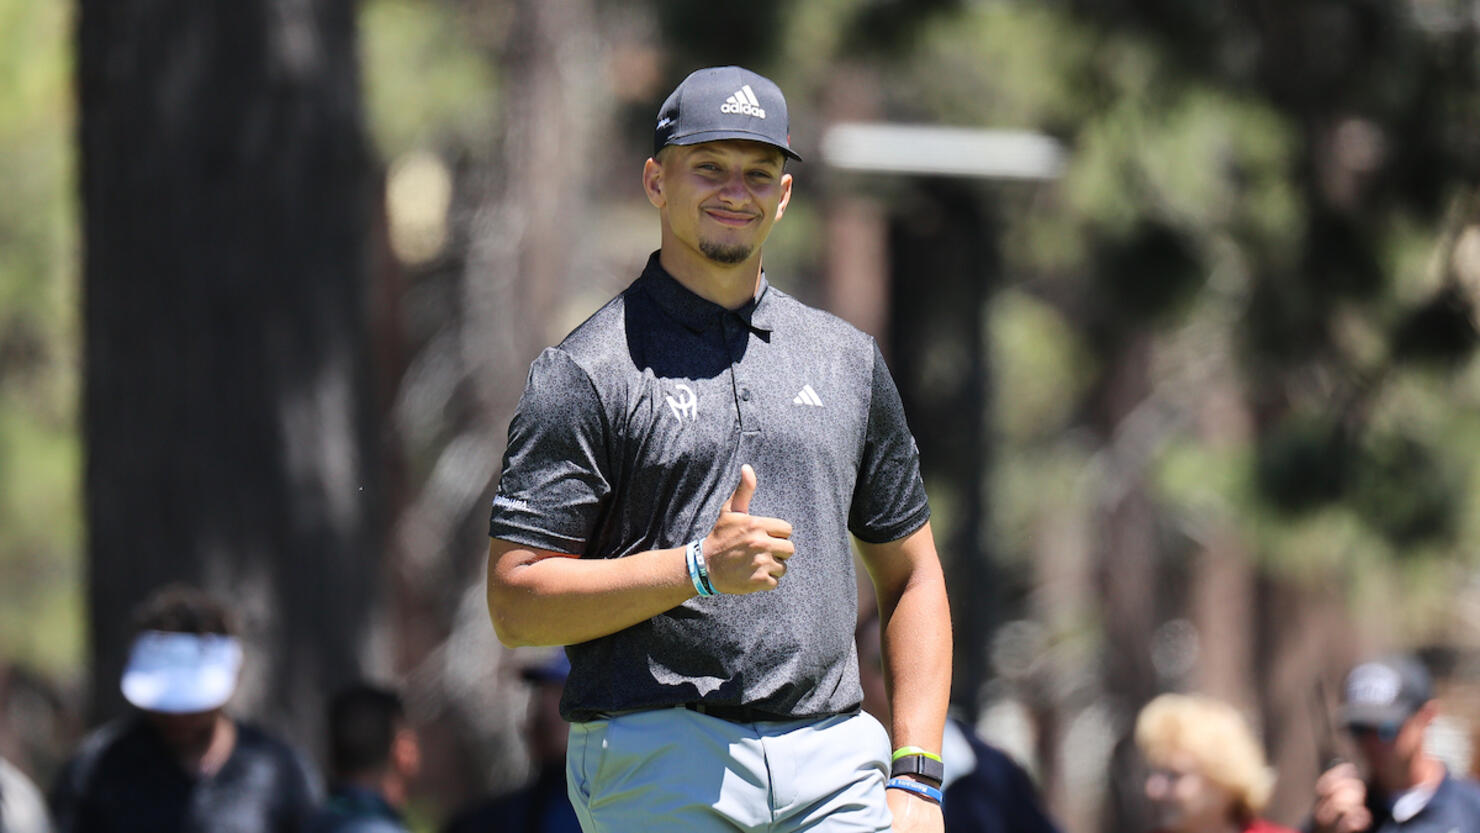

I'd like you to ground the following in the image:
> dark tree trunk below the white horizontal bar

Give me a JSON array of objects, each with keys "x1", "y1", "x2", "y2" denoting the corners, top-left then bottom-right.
[{"x1": 888, "y1": 179, "x2": 1006, "y2": 715}]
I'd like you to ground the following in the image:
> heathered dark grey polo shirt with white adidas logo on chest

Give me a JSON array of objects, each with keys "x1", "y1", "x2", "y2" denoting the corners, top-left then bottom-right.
[{"x1": 490, "y1": 253, "x2": 929, "y2": 721}]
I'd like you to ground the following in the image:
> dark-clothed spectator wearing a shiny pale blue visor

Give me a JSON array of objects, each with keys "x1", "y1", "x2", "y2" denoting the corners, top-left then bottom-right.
[{"x1": 52, "y1": 584, "x2": 321, "y2": 833}]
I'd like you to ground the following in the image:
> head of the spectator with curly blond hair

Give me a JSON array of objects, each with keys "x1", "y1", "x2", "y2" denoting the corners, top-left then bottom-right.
[{"x1": 1135, "y1": 694, "x2": 1292, "y2": 833}]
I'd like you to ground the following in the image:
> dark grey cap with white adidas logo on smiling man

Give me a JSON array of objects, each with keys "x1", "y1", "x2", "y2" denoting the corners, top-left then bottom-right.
[{"x1": 653, "y1": 67, "x2": 802, "y2": 161}]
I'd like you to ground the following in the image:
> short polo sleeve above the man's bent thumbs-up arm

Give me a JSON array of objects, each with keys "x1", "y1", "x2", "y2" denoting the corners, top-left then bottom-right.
[{"x1": 488, "y1": 348, "x2": 611, "y2": 555}]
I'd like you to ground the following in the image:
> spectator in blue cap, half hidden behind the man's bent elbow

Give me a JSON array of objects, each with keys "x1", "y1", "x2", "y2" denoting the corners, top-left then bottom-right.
[{"x1": 444, "y1": 651, "x2": 580, "y2": 833}]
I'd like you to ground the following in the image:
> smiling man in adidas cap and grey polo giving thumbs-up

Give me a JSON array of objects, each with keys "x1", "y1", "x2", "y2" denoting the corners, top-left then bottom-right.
[{"x1": 488, "y1": 67, "x2": 950, "y2": 833}]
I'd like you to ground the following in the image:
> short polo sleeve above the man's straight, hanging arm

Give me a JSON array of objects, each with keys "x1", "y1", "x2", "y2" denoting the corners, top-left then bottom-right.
[{"x1": 848, "y1": 345, "x2": 929, "y2": 543}]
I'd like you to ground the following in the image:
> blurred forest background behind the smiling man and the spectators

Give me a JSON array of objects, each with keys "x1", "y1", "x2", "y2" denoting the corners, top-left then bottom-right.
[{"x1": 0, "y1": 0, "x2": 1480, "y2": 833}]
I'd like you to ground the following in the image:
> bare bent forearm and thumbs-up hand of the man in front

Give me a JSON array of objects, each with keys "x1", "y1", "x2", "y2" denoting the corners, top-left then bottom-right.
[{"x1": 488, "y1": 466, "x2": 793, "y2": 647}]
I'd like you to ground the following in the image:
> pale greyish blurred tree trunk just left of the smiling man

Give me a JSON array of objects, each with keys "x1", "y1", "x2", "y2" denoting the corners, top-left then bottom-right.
[{"x1": 395, "y1": 0, "x2": 606, "y2": 806}]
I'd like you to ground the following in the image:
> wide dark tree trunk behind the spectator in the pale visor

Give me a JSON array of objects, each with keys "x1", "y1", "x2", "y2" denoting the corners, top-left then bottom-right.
[{"x1": 77, "y1": 0, "x2": 382, "y2": 744}]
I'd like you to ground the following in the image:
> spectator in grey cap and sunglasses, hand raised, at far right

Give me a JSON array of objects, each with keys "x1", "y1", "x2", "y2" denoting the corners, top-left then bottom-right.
[{"x1": 1313, "y1": 655, "x2": 1480, "y2": 833}]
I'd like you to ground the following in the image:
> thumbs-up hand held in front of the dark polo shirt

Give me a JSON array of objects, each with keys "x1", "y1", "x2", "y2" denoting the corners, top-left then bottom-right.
[{"x1": 702, "y1": 465, "x2": 796, "y2": 593}]
